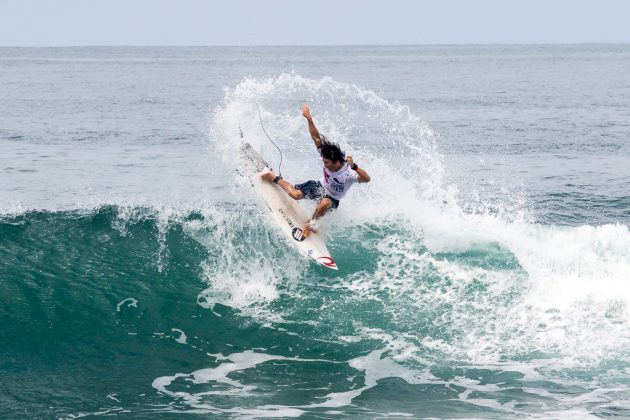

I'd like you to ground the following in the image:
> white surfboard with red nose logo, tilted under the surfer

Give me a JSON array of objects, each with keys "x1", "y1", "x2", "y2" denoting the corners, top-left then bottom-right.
[{"x1": 241, "y1": 142, "x2": 338, "y2": 270}]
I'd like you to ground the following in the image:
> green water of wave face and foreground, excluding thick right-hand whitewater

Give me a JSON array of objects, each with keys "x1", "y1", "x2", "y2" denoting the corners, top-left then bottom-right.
[{"x1": 0, "y1": 207, "x2": 629, "y2": 418}]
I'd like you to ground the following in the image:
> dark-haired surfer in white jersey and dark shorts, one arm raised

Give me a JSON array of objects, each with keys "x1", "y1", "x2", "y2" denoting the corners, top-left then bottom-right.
[{"x1": 261, "y1": 104, "x2": 370, "y2": 237}]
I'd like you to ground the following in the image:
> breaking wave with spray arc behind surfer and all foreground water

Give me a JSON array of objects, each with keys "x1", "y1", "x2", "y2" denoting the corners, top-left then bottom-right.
[{"x1": 0, "y1": 46, "x2": 630, "y2": 419}]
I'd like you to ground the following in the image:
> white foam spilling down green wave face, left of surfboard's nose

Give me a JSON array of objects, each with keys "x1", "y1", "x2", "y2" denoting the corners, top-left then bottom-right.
[{"x1": 184, "y1": 206, "x2": 307, "y2": 319}]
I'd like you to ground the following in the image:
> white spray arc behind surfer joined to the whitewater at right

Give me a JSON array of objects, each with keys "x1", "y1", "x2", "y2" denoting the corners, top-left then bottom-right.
[{"x1": 211, "y1": 74, "x2": 630, "y2": 364}]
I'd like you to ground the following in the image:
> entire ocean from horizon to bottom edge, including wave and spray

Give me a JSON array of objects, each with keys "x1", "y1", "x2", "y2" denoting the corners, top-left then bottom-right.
[{"x1": 0, "y1": 45, "x2": 630, "y2": 419}]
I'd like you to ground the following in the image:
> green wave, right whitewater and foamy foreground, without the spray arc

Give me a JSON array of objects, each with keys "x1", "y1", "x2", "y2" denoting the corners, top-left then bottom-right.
[{"x1": 0, "y1": 206, "x2": 630, "y2": 418}]
